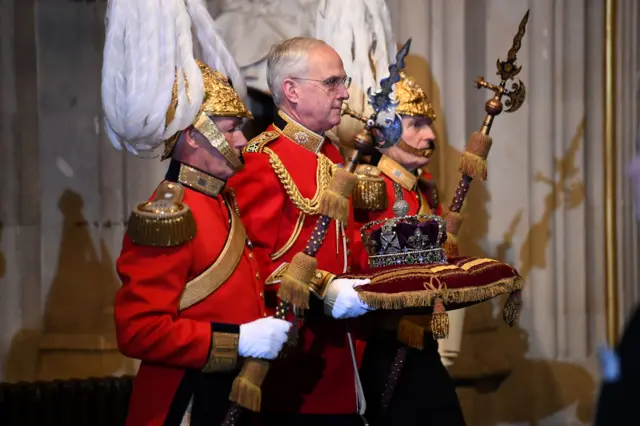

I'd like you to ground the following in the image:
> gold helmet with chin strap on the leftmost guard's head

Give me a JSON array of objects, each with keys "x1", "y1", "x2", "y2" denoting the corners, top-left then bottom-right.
[{"x1": 162, "y1": 60, "x2": 253, "y2": 165}]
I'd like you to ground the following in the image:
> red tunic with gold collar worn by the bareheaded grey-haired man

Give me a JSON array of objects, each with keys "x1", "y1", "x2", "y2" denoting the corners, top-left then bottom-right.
[{"x1": 229, "y1": 111, "x2": 356, "y2": 414}]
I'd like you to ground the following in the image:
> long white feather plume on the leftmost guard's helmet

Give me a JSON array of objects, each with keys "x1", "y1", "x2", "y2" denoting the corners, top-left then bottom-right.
[{"x1": 101, "y1": 0, "x2": 246, "y2": 155}]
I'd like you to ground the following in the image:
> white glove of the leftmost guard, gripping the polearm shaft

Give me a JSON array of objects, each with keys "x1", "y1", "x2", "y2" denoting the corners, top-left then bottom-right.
[{"x1": 238, "y1": 317, "x2": 291, "y2": 359}]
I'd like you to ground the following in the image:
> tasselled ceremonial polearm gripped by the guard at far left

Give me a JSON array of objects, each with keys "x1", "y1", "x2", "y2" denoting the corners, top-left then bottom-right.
[{"x1": 223, "y1": 39, "x2": 411, "y2": 426}]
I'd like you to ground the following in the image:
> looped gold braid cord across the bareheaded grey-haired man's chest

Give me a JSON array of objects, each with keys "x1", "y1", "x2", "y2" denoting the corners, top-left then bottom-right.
[{"x1": 263, "y1": 147, "x2": 338, "y2": 216}]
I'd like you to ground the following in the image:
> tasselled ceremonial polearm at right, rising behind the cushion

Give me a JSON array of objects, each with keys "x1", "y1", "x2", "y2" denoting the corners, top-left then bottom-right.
[{"x1": 382, "y1": 10, "x2": 529, "y2": 411}]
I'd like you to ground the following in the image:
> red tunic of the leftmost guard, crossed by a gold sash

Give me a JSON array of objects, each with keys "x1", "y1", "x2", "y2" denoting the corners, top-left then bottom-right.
[{"x1": 115, "y1": 162, "x2": 266, "y2": 426}]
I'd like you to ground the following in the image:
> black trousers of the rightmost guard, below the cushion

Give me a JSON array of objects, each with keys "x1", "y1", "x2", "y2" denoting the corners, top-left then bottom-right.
[{"x1": 360, "y1": 331, "x2": 465, "y2": 426}]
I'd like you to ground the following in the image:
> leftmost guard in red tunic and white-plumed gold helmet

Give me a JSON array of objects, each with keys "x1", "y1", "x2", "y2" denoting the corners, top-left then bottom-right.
[{"x1": 102, "y1": 0, "x2": 290, "y2": 426}]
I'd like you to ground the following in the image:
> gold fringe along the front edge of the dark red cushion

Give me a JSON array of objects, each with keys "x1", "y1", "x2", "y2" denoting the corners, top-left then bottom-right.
[{"x1": 355, "y1": 276, "x2": 524, "y2": 311}]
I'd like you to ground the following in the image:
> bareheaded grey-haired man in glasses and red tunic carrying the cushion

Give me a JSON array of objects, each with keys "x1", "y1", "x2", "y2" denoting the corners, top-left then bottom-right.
[{"x1": 229, "y1": 37, "x2": 371, "y2": 426}]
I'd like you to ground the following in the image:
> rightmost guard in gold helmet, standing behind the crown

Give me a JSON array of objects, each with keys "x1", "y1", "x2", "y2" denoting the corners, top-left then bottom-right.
[{"x1": 354, "y1": 74, "x2": 465, "y2": 426}]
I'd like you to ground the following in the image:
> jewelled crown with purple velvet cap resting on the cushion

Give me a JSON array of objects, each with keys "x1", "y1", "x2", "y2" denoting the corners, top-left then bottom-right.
[{"x1": 360, "y1": 215, "x2": 447, "y2": 268}]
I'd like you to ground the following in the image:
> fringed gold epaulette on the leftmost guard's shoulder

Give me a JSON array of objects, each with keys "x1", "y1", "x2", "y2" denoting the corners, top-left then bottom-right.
[{"x1": 127, "y1": 181, "x2": 196, "y2": 247}]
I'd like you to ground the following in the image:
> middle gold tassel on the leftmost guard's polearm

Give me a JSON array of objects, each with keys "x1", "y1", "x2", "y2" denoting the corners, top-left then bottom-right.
[{"x1": 278, "y1": 252, "x2": 318, "y2": 309}]
